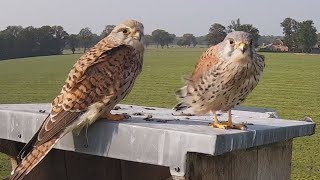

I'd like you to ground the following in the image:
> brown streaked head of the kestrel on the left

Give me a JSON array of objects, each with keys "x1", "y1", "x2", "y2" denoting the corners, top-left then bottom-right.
[{"x1": 109, "y1": 19, "x2": 144, "y2": 50}]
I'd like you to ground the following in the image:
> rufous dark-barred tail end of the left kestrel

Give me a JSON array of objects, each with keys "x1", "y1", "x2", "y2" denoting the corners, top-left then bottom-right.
[{"x1": 10, "y1": 138, "x2": 59, "y2": 180}]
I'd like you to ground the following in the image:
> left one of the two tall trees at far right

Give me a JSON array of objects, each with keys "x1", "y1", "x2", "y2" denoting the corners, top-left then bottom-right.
[{"x1": 280, "y1": 18, "x2": 299, "y2": 51}]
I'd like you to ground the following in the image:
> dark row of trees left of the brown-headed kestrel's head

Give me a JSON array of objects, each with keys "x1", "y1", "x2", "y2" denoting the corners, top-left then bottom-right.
[{"x1": 0, "y1": 25, "x2": 115, "y2": 60}]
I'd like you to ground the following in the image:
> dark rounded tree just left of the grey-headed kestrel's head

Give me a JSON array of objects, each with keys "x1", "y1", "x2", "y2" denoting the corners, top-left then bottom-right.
[{"x1": 207, "y1": 23, "x2": 227, "y2": 45}]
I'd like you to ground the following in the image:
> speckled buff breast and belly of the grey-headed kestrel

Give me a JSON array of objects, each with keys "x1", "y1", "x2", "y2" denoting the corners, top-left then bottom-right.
[{"x1": 201, "y1": 63, "x2": 258, "y2": 111}]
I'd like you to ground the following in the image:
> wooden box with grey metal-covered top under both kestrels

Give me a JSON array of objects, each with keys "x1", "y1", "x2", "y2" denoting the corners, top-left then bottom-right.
[{"x1": 0, "y1": 104, "x2": 315, "y2": 180}]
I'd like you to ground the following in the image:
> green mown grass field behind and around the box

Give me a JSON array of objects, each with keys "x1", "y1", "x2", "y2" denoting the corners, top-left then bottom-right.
[{"x1": 0, "y1": 48, "x2": 320, "y2": 179}]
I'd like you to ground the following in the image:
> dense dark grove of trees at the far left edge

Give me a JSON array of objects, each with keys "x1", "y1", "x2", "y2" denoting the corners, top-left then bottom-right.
[{"x1": 0, "y1": 26, "x2": 68, "y2": 59}]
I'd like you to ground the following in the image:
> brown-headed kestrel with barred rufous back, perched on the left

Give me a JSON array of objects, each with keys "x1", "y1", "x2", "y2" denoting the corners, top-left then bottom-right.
[{"x1": 11, "y1": 20, "x2": 144, "y2": 180}]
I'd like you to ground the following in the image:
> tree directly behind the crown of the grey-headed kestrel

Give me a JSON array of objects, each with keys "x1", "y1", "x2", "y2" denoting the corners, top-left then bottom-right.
[{"x1": 228, "y1": 18, "x2": 260, "y2": 47}]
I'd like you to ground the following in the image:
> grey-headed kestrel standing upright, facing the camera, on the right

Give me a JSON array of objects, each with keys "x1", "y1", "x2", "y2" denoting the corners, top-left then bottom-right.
[{"x1": 174, "y1": 31, "x2": 265, "y2": 129}]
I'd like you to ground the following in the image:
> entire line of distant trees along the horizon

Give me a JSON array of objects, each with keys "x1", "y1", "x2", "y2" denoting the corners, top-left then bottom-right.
[{"x1": 0, "y1": 18, "x2": 320, "y2": 60}]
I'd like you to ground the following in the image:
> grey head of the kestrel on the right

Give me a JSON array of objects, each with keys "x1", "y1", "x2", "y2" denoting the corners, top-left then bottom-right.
[{"x1": 222, "y1": 31, "x2": 255, "y2": 61}]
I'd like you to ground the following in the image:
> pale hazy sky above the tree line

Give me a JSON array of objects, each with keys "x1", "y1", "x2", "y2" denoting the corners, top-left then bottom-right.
[{"x1": 0, "y1": 0, "x2": 320, "y2": 36}]
